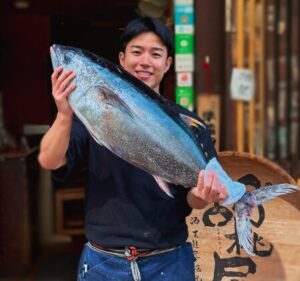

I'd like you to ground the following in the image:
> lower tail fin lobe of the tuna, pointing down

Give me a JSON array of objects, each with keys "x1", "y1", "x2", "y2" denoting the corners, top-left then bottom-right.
[{"x1": 235, "y1": 200, "x2": 255, "y2": 256}]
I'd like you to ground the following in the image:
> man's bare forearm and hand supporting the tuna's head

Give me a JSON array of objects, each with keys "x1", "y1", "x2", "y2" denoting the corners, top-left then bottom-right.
[{"x1": 38, "y1": 67, "x2": 76, "y2": 169}]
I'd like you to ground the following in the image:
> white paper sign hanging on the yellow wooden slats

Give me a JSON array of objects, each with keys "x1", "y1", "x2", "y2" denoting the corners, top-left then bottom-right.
[{"x1": 230, "y1": 68, "x2": 255, "y2": 101}]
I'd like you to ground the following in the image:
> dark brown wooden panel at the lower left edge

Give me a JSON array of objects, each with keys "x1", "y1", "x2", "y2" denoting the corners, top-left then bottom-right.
[{"x1": 0, "y1": 149, "x2": 37, "y2": 277}]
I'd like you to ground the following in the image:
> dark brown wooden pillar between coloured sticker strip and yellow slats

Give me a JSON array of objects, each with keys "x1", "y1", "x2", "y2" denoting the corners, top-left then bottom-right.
[{"x1": 194, "y1": 0, "x2": 227, "y2": 150}]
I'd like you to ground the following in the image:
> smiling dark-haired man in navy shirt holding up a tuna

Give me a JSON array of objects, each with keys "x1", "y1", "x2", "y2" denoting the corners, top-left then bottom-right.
[{"x1": 39, "y1": 18, "x2": 227, "y2": 281}]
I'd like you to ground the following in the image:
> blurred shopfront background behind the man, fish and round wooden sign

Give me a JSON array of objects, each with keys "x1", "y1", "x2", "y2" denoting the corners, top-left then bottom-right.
[{"x1": 0, "y1": 0, "x2": 300, "y2": 281}]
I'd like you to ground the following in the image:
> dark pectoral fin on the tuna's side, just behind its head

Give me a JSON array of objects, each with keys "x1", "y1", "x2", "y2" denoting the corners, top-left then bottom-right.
[{"x1": 96, "y1": 86, "x2": 133, "y2": 116}]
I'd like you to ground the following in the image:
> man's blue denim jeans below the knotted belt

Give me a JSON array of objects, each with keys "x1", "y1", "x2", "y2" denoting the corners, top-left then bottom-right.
[{"x1": 77, "y1": 243, "x2": 195, "y2": 281}]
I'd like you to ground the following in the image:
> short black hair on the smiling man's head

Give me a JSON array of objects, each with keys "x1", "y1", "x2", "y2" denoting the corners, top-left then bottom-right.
[{"x1": 120, "y1": 17, "x2": 174, "y2": 56}]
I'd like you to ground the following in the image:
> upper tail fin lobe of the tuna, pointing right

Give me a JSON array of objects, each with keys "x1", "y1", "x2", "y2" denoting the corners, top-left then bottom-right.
[{"x1": 251, "y1": 183, "x2": 300, "y2": 206}]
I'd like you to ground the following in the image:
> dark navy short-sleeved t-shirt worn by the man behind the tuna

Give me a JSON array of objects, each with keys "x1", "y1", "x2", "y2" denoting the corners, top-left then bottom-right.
[{"x1": 54, "y1": 104, "x2": 216, "y2": 249}]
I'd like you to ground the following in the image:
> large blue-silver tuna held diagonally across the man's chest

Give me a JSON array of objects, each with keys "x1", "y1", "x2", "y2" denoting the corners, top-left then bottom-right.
[{"x1": 50, "y1": 45, "x2": 298, "y2": 255}]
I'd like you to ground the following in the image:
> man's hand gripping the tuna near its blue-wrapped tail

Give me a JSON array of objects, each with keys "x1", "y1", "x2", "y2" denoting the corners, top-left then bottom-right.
[{"x1": 187, "y1": 170, "x2": 227, "y2": 209}]
